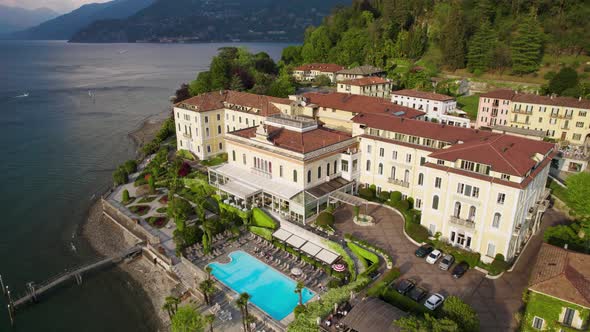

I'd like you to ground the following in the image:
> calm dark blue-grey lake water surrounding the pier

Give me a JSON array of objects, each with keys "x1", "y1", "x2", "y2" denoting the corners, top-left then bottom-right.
[{"x1": 0, "y1": 41, "x2": 287, "y2": 332}]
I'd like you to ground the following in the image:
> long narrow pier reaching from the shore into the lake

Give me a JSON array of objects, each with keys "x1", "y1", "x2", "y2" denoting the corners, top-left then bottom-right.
[{"x1": 0, "y1": 244, "x2": 142, "y2": 323}]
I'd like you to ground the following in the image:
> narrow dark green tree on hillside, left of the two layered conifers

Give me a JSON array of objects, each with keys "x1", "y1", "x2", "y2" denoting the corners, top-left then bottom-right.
[{"x1": 440, "y1": 5, "x2": 465, "y2": 70}]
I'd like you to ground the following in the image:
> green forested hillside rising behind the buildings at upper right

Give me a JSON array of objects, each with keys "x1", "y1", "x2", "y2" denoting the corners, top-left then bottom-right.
[{"x1": 283, "y1": 0, "x2": 590, "y2": 82}]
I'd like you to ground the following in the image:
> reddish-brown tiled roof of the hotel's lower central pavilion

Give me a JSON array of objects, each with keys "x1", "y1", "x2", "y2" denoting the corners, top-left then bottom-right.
[{"x1": 229, "y1": 125, "x2": 354, "y2": 153}]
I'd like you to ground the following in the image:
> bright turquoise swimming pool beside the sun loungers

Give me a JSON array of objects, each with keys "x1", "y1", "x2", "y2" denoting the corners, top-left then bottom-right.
[{"x1": 209, "y1": 250, "x2": 314, "y2": 320}]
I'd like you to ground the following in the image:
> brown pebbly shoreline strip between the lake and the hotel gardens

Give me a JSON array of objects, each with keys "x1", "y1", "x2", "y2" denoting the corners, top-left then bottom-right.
[{"x1": 82, "y1": 110, "x2": 177, "y2": 331}]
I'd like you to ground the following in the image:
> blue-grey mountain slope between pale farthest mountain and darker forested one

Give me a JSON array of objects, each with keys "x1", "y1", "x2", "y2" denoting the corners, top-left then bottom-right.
[{"x1": 10, "y1": 0, "x2": 154, "y2": 40}]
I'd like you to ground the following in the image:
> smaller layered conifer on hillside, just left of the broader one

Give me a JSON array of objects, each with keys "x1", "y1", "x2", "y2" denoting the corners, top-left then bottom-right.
[{"x1": 467, "y1": 20, "x2": 497, "y2": 72}]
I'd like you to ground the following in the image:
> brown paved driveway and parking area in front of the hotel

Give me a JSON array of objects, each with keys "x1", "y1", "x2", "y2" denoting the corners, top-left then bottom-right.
[{"x1": 334, "y1": 205, "x2": 564, "y2": 331}]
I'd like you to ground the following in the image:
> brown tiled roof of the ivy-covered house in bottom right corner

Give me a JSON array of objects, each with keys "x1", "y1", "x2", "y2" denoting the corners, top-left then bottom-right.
[{"x1": 529, "y1": 243, "x2": 590, "y2": 308}]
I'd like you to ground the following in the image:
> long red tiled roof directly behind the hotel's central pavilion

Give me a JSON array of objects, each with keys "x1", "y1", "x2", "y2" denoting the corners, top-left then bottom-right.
[{"x1": 303, "y1": 92, "x2": 424, "y2": 118}]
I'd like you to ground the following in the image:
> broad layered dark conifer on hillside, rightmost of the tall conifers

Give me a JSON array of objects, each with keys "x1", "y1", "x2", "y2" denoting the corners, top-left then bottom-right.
[{"x1": 511, "y1": 12, "x2": 543, "y2": 74}]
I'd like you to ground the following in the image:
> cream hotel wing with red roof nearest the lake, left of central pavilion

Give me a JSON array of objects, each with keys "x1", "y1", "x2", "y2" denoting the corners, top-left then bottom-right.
[{"x1": 174, "y1": 91, "x2": 292, "y2": 159}]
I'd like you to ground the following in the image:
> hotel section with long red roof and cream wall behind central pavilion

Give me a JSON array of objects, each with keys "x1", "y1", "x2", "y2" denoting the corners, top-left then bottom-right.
[{"x1": 295, "y1": 92, "x2": 424, "y2": 132}]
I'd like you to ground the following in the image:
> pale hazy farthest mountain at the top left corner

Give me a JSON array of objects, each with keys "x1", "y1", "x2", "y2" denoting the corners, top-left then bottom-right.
[{"x1": 0, "y1": 5, "x2": 59, "y2": 34}]
